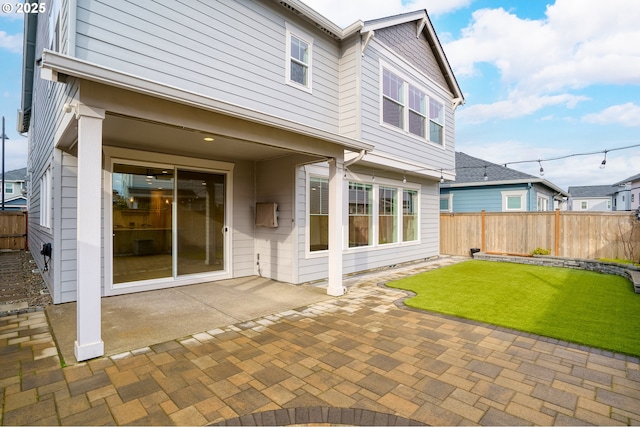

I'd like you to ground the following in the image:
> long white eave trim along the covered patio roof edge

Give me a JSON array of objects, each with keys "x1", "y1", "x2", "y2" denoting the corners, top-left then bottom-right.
[{"x1": 39, "y1": 49, "x2": 374, "y2": 152}]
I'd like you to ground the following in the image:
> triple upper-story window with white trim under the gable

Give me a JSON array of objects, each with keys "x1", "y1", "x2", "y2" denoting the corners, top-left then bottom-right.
[{"x1": 381, "y1": 68, "x2": 444, "y2": 145}]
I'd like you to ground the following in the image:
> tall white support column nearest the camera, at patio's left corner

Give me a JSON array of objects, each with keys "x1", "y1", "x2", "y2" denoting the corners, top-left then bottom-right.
[{"x1": 75, "y1": 105, "x2": 104, "y2": 361}]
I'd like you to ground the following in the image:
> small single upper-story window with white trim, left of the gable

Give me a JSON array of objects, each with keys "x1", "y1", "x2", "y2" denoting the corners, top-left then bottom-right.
[{"x1": 286, "y1": 24, "x2": 313, "y2": 92}]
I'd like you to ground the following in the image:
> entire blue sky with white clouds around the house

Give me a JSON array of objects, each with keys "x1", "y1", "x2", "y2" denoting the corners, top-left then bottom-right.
[{"x1": 0, "y1": 0, "x2": 640, "y2": 190}]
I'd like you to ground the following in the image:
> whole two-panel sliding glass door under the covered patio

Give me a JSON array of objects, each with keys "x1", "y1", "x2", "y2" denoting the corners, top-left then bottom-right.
[{"x1": 112, "y1": 164, "x2": 227, "y2": 284}]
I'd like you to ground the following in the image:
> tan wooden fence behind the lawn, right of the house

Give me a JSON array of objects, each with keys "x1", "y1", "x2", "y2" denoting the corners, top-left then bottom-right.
[{"x1": 440, "y1": 210, "x2": 640, "y2": 261}]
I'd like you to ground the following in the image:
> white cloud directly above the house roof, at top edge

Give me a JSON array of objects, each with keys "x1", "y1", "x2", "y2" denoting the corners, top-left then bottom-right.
[{"x1": 303, "y1": 0, "x2": 473, "y2": 28}]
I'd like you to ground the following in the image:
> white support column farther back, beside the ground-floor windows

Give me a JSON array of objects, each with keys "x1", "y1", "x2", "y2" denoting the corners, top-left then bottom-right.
[{"x1": 327, "y1": 156, "x2": 344, "y2": 297}]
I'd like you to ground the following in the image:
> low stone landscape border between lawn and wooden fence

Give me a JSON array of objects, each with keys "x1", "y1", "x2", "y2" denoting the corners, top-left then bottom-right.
[{"x1": 473, "y1": 252, "x2": 640, "y2": 294}]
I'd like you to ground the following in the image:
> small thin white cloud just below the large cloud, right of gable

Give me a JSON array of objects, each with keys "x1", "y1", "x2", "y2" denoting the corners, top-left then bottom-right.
[{"x1": 456, "y1": 92, "x2": 589, "y2": 123}]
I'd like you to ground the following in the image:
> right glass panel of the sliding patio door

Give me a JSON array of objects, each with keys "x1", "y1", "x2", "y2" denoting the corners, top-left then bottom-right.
[{"x1": 176, "y1": 170, "x2": 226, "y2": 275}]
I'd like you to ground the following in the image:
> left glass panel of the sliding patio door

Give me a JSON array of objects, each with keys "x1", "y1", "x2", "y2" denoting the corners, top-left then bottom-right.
[{"x1": 112, "y1": 164, "x2": 174, "y2": 284}]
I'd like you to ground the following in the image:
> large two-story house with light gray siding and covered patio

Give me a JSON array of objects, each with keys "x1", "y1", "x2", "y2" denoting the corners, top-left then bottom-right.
[{"x1": 18, "y1": 0, "x2": 464, "y2": 360}]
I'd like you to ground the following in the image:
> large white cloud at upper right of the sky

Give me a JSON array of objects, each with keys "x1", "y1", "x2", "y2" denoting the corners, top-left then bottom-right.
[{"x1": 444, "y1": 0, "x2": 640, "y2": 93}]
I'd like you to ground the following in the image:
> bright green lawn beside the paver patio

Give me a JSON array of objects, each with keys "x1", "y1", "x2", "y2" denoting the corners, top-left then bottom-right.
[{"x1": 387, "y1": 260, "x2": 640, "y2": 356}]
